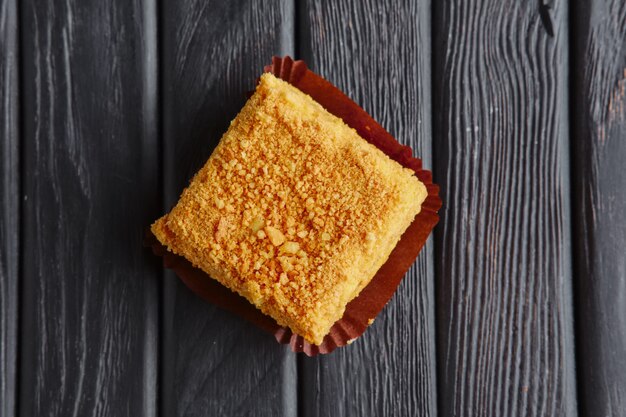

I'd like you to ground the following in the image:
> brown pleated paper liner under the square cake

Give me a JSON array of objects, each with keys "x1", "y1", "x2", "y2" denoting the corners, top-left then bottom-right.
[{"x1": 146, "y1": 57, "x2": 441, "y2": 356}]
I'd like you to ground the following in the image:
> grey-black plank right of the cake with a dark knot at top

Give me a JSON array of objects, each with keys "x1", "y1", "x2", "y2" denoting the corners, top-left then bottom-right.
[{"x1": 433, "y1": 0, "x2": 577, "y2": 416}]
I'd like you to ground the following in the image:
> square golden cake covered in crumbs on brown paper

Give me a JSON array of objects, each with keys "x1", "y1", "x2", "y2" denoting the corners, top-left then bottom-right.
[{"x1": 152, "y1": 73, "x2": 427, "y2": 345}]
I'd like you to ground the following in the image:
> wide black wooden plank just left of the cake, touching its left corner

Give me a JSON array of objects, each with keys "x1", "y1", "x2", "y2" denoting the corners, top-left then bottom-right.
[{"x1": 19, "y1": 0, "x2": 159, "y2": 417}]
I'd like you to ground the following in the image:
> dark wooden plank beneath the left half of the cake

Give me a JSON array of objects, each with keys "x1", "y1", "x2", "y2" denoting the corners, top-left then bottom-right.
[{"x1": 162, "y1": 0, "x2": 297, "y2": 416}]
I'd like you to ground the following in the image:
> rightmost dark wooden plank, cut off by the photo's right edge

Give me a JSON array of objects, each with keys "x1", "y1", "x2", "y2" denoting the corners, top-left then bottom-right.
[{"x1": 571, "y1": 0, "x2": 626, "y2": 417}]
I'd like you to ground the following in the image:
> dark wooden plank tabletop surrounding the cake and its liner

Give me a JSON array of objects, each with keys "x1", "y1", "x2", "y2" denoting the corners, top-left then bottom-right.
[{"x1": 0, "y1": 0, "x2": 626, "y2": 417}]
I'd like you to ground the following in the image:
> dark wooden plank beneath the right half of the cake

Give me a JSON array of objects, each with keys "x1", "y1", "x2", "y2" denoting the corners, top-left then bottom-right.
[{"x1": 299, "y1": 0, "x2": 436, "y2": 416}]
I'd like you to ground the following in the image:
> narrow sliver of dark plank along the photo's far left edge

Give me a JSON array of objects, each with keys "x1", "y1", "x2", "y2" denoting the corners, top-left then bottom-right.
[{"x1": 0, "y1": 0, "x2": 20, "y2": 416}]
